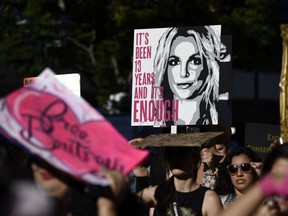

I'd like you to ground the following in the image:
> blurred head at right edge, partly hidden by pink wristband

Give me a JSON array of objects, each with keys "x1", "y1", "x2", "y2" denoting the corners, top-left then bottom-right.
[{"x1": 261, "y1": 143, "x2": 288, "y2": 215}]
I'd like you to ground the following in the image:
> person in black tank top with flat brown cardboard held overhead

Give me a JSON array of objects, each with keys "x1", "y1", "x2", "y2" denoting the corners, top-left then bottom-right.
[{"x1": 133, "y1": 133, "x2": 222, "y2": 216}]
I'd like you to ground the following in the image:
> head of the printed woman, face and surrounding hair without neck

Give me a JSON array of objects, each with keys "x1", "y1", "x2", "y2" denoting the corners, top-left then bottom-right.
[{"x1": 154, "y1": 26, "x2": 220, "y2": 100}]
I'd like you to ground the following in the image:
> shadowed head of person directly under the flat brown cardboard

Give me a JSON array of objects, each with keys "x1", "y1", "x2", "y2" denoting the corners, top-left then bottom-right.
[{"x1": 164, "y1": 147, "x2": 200, "y2": 181}]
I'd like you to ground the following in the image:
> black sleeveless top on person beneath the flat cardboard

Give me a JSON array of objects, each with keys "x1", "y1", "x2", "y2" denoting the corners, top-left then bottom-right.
[{"x1": 154, "y1": 186, "x2": 209, "y2": 216}]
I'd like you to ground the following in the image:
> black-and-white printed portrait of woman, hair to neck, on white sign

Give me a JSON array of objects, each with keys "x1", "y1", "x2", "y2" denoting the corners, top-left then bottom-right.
[{"x1": 154, "y1": 26, "x2": 221, "y2": 126}]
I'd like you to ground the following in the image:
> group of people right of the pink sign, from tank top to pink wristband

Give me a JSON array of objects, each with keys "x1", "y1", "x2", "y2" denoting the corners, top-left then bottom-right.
[{"x1": 130, "y1": 128, "x2": 288, "y2": 216}]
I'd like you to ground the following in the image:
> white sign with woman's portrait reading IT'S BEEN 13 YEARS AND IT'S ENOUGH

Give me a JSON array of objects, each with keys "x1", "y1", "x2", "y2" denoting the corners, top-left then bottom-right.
[{"x1": 131, "y1": 25, "x2": 226, "y2": 127}]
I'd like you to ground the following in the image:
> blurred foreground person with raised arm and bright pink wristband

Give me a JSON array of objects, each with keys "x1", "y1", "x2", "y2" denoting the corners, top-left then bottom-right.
[{"x1": 219, "y1": 143, "x2": 288, "y2": 216}]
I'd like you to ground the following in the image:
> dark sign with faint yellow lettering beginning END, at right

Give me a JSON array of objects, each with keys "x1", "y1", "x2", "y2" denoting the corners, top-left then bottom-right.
[{"x1": 245, "y1": 123, "x2": 280, "y2": 160}]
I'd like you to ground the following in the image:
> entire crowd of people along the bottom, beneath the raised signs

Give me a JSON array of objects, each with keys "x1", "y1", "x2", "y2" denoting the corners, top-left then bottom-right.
[{"x1": 0, "y1": 125, "x2": 288, "y2": 216}]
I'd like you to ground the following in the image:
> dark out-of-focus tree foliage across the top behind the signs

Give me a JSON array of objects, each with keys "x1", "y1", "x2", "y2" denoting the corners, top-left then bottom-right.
[{"x1": 0, "y1": 0, "x2": 282, "y2": 104}]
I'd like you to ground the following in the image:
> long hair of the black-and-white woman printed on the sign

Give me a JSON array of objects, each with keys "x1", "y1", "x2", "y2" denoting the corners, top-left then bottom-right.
[{"x1": 154, "y1": 26, "x2": 221, "y2": 126}]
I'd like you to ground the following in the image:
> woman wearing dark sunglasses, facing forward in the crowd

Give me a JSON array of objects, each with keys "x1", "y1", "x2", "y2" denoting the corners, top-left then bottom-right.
[{"x1": 216, "y1": 147, "x2": 261, "y2": 208}]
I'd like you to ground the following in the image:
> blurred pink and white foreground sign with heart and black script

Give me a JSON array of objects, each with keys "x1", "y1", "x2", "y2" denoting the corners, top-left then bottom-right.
[{"x1": 0, "y1": 69, "x2": 148, "y2": 185}]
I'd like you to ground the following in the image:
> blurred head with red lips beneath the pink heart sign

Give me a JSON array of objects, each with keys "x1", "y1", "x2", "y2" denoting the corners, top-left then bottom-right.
[{"x1": 31, "y1": 158, "x2": 96, "y2": 216}]
